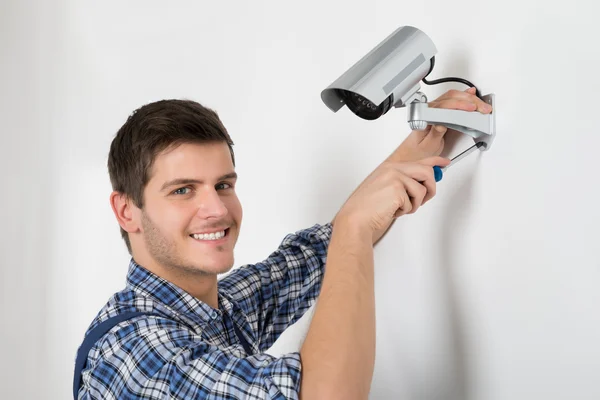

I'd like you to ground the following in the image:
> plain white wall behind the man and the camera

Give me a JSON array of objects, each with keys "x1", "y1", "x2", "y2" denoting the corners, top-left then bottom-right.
[{"x1": 0, "y1": 0, "x2": 600, "y2": 400}]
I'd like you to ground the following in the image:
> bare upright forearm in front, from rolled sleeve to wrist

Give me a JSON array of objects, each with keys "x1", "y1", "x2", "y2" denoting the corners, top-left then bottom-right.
[{"x1": 300, "y1": 220, "x2": 375, "y2": 400}]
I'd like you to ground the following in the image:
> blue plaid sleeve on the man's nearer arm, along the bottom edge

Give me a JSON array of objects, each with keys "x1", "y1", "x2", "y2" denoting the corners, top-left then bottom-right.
[{"x1": 79, "y1": 319, "x2": 301, "y2": 400}]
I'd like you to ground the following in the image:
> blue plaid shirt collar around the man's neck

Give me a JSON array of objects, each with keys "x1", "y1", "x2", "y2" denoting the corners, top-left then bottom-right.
[{"x1": 127, "y1": 258, "x2": 229, "y2": 322}]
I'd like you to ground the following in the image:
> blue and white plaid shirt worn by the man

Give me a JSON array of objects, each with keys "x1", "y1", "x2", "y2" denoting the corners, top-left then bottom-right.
[{"x1": 79, "y1": 223, "x2": 332, "y2": 399}]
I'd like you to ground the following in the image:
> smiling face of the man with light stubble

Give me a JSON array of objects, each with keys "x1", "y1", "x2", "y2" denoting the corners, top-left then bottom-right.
[{"x1": 140, "y1": 142, "x2": 242, "y2": 274}]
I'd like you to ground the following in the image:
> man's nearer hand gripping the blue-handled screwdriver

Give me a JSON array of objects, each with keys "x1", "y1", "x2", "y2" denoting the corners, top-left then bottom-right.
[{"x1": 335, "y1": 157, "x2": 450, "y2": 244}]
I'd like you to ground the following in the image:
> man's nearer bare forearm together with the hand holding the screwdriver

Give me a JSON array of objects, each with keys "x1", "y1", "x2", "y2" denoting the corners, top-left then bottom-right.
[{"x1": 300, "y1": 157, "x2": 449, "y2": 399}]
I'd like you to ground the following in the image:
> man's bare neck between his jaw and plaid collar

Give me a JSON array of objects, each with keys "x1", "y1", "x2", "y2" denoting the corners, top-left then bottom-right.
[{"x1": 136, "y1": 255, "x2": 219, "y2": 309}]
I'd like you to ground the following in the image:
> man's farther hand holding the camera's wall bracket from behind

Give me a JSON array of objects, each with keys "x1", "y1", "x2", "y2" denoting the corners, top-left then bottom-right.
[{"x1": 390, "y1": 88, "x2": 492, "y2": 161}]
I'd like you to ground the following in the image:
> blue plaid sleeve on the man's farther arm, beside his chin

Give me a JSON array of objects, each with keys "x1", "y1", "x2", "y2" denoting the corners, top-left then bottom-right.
[{"x1": 219, "y1": 223, "x2": 332, "y2": 351}]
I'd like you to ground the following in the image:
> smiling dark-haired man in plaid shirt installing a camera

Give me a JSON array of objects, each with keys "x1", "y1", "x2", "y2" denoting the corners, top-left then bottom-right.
[{"x1": 74, "y1": 89, "x2": 491, "y2": 399}]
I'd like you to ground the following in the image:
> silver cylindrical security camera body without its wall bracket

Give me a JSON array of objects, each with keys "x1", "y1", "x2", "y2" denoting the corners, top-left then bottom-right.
[{"x1": 321, "y1": 26, "x2": 437, "y2": 120}]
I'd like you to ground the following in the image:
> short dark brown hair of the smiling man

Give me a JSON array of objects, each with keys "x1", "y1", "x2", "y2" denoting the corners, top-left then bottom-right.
[{"x1": 108, "y1": 99, "x2": 235, "y2": 254}]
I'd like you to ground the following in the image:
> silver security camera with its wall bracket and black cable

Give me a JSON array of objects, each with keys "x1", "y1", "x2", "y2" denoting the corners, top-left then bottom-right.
[{"x1": 321, "y1": 26, "x2": 497, "y2": 151}]
